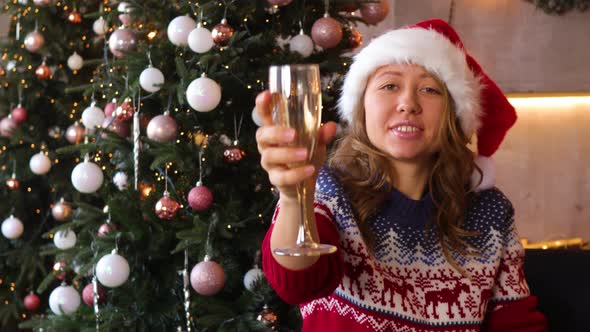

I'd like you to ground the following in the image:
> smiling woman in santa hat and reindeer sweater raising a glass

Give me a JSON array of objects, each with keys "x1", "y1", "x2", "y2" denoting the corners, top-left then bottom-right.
[{"x1": 256, "y1": 20, "x2": 546, "y2": 332}]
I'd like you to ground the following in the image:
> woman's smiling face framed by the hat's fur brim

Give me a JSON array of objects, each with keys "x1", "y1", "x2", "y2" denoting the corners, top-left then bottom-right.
[{"x1": 364, "y1": 64, "x2": 445, "y2": 163}]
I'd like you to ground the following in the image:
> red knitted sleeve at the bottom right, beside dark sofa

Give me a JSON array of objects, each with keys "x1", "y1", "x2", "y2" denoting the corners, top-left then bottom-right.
[{"x1": 482, "y1": 296, "x2": 548, "y2": 332}]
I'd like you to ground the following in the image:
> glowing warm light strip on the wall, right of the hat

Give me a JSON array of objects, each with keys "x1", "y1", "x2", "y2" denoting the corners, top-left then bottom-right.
[{"x1": 506, "y1": 93, "x2": 590, "y2": 108}]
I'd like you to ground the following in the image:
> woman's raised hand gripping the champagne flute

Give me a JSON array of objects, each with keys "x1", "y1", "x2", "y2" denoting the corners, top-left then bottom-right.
[{"x1": 256, "y1": 90, "x2": 336, "y2": 201}]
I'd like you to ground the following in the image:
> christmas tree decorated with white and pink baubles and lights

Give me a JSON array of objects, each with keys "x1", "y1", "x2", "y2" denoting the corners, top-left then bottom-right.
[{"x1": 0, "y1": 0, "x2": 388, "y2": 332}]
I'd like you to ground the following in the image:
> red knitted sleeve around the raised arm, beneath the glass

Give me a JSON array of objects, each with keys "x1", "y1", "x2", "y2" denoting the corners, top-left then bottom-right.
[{"x1": 261, "y1": 203, "x2": 344, "y2": 304}]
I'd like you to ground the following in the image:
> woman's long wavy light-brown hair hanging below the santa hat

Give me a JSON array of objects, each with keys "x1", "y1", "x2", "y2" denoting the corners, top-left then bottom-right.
[{"x1": 328, "y1": 74, "x2": 481, "y2": 274}]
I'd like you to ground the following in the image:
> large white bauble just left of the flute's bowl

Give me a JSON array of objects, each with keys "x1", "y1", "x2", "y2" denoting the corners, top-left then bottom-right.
[{"x1": 186, "y1": 76, "x2": 221, "y2": 112}]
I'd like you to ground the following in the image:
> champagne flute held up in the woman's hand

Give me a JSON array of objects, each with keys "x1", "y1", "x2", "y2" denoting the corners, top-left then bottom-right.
[{"x1": 268, "y1": 64, "x2": 337, "y2": 256}]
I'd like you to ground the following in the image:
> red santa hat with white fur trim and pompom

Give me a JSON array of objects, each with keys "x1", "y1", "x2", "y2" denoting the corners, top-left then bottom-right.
[{"x1": 338, "y1": 19, "x2": 516, "y2": 190}]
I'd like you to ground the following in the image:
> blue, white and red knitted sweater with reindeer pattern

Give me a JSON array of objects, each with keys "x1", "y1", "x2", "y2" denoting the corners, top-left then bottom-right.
[{"x1": 262, "y1": 168, "x2": 546, "y2": 332}]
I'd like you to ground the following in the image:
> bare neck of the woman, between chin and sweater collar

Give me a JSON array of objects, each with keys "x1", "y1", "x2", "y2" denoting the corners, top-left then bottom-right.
[{"x1": 393, "y1": 161, "x2": 430, "y2": 200}]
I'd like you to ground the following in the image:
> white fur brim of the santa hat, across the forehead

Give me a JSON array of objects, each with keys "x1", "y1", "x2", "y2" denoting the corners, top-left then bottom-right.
[{"x1": 338, "y1": 27, "x2": 481, "y2": 135}]
